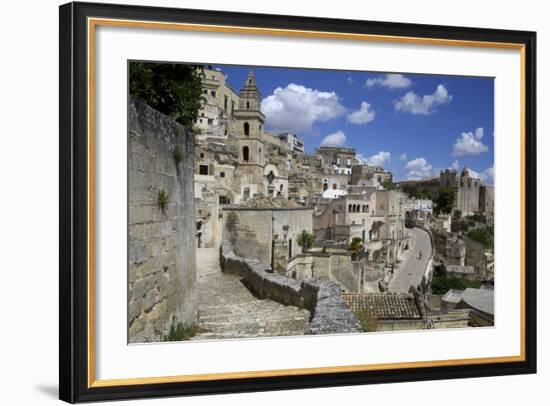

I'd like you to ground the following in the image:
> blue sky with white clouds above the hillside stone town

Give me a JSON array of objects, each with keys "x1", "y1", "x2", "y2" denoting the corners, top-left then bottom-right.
[{"x1": 214, "y1": 66, "x2": 494, "y2": 184}]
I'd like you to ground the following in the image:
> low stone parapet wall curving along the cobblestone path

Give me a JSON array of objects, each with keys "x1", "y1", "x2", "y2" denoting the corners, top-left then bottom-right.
[{"x1": 220, "y1": 240, "x2": 363, "y2": 334}]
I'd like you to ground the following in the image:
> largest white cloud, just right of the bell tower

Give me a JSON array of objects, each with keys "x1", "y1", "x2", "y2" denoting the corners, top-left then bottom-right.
[{"x1": 261, "y1": 83, "x2": 345, "y2": 133}]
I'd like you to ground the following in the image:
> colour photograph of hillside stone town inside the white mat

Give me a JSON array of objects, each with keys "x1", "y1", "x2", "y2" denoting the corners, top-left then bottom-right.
[{"x1": 127, "y1": 60, "x2": 501, "y2": 345}]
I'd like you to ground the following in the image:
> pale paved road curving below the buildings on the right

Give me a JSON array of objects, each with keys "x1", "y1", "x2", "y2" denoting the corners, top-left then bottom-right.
[{"x1": 389, "y1": 227, "x2": 432, "y2": 293}]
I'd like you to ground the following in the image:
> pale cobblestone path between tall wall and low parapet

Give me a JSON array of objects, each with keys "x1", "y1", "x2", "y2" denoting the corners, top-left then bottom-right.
[{"x1": 192, "y1": 248, "x2": 309, "y2": 340}]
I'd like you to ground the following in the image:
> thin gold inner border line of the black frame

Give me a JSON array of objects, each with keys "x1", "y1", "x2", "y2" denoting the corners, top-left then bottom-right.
[{"x1": 87, "y1": 18, "x2": 526, "y2": 388}]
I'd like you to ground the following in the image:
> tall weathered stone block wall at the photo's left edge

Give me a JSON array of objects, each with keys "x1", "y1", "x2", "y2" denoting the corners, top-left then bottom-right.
[{"x1": 128, "y1": 98, "x2": 197, "y2": 343}]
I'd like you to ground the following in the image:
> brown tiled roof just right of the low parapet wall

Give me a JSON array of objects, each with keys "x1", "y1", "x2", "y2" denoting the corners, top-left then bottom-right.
[{"x1": 342, "y1": 293, "x2": 421, "y2": 320}]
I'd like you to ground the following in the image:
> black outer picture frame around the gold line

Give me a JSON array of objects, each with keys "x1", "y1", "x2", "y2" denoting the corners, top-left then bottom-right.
[{"x1": 59, "y1": 3, "x2": 537, "y2": 403}]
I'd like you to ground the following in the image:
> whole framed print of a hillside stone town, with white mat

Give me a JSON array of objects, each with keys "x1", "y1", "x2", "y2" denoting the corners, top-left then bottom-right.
[{"x1": 60, "y1": 3, "x2": 536, "y2": 402}]
